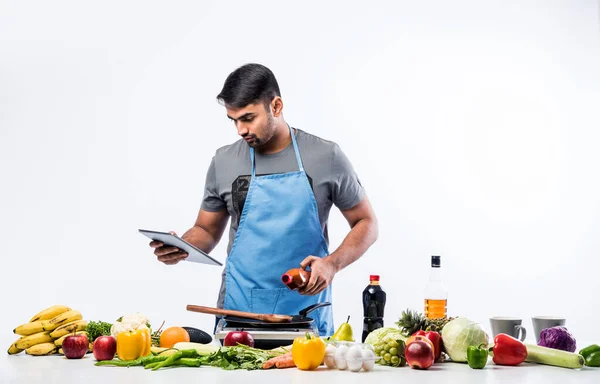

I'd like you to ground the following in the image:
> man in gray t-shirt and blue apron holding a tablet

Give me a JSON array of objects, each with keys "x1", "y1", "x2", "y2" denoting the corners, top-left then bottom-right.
[{"x1": 150, "y1": 64, "x2": 378, "y2": 336}]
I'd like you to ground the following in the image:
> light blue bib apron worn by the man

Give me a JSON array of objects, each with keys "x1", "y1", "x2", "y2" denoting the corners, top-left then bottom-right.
[{"x1": 224, "y1": 127, "x2": 334, "y2": 336}]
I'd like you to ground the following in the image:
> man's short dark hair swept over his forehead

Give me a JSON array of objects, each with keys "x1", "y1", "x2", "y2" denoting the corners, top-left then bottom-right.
[{"x1": 217, "y1": 64, "x2": 281, "y2": 110}]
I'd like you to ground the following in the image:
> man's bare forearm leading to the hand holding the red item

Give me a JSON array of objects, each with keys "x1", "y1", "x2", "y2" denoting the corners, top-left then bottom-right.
[{"x1": 326, "y1": 218, "x2": 379, "y2": 273}]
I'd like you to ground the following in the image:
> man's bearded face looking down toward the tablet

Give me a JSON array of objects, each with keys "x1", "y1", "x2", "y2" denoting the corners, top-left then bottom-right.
[{"x1": 225, "y1": 102, "x2": 275, "y2": 148}]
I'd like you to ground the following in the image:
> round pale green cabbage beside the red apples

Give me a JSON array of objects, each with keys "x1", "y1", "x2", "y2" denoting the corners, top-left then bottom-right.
[{"x1": 442, "y1": 317, "x2": 489, "y2": 363}]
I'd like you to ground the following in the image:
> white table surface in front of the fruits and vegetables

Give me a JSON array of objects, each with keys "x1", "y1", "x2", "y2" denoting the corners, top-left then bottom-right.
[{"x1": 0, "y1": 346, "x2": 600, "y2": 384}]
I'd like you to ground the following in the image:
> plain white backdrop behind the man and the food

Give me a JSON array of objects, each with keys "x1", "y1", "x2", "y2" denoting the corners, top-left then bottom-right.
[{"x1": 0, "y1": 0, "x2": 600, "y2": 347}]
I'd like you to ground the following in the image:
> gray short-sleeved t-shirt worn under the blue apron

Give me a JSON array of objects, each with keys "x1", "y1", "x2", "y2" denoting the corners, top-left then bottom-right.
[{"x1": 202, "y1": 129, "x2": 365, "y2": 308}]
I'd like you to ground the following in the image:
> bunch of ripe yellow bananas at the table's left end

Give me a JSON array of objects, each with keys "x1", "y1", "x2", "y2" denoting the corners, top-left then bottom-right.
[{"x1": 8, "y1": 305, "x2": 88, "y2": 356}]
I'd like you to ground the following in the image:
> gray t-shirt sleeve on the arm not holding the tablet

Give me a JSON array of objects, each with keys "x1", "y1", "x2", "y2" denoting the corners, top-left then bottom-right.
[{"x1": 331, "y1": 144, "x2": 365, "y2": 211}]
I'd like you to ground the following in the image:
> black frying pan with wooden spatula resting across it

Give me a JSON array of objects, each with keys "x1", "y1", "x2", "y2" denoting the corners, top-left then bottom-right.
[{"x1": 186, "y1": 302, "x2": 331, "y2": 328}]
